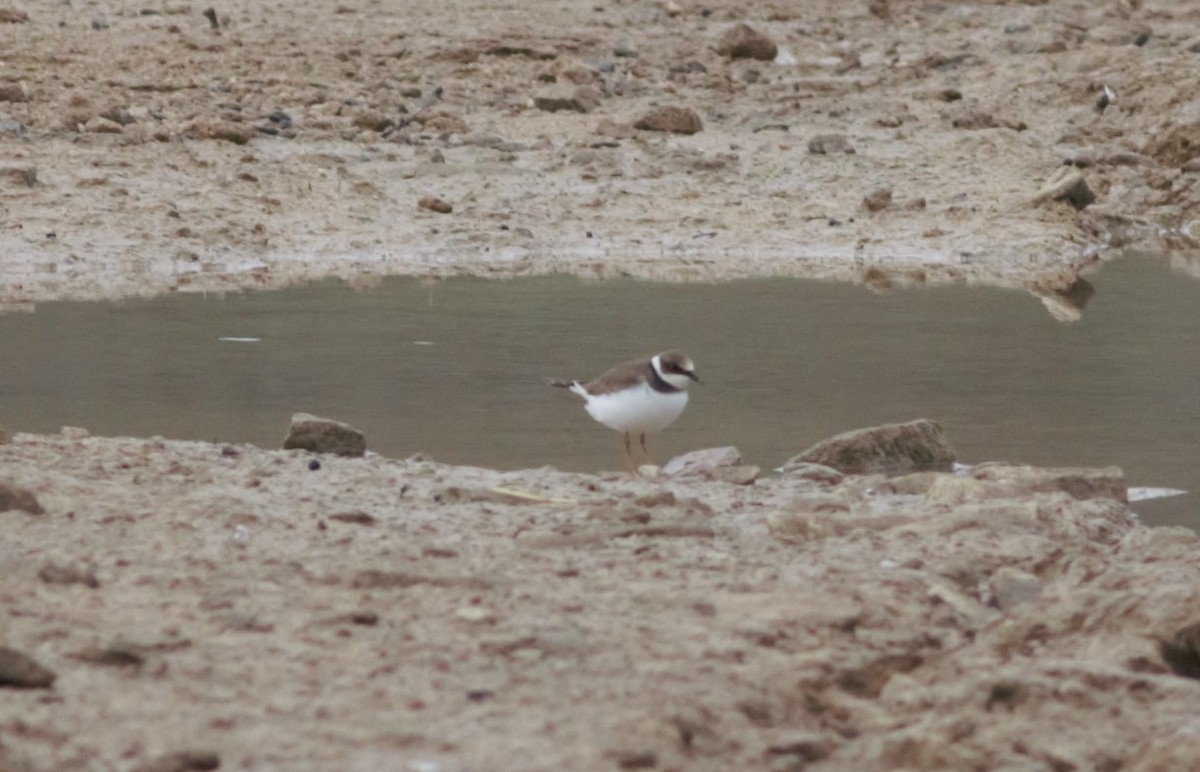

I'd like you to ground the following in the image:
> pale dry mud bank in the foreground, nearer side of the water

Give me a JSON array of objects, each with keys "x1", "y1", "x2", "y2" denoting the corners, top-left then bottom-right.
[{"x1": 0, "y1": 432, "x2": 1200, "y2": 771}]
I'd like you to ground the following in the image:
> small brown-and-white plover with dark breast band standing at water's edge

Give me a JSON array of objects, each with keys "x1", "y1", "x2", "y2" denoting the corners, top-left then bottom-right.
[{"x1": 550, "y1": 349, "x2": 700, "y2": 474}]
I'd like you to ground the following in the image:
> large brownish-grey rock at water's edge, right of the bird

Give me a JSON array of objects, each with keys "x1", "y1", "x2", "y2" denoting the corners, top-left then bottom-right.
[{"x1": 788, "y1": 419, "x2": 955, "y2": 474}]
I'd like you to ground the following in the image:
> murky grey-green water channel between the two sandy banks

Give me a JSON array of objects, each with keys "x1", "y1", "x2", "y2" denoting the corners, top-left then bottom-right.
[{"x1": 0, "y1": 258, "x2": 1200, "y2": 526}]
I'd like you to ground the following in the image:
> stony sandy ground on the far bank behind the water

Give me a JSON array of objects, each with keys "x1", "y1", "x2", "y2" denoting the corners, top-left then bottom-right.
[{"x1": 0, "y1": 0, "x2": 1200, "y2": 304}]
